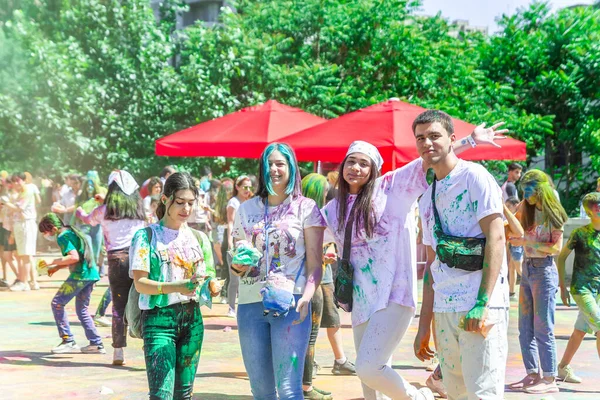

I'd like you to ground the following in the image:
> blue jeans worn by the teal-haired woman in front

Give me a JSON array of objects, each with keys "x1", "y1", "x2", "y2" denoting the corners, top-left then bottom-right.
[{"x1": 237, "y1": 295, "x2": 311, "y2": 400}]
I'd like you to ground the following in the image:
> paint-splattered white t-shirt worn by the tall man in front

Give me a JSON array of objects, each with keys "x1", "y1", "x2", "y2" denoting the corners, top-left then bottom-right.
[{"x1": 419, "y1": 160, "x2": 509, "y2": 312}]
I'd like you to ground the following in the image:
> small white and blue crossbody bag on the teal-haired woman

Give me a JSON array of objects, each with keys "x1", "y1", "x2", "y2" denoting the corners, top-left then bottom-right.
[{"x1": 260, "y1": 199, "x2": 305, "y2": 317}]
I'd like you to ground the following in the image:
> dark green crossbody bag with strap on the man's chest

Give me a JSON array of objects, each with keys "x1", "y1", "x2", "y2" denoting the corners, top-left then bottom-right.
[{"x1": 431, "y1": 179, "x2": 486, "y2": 271}]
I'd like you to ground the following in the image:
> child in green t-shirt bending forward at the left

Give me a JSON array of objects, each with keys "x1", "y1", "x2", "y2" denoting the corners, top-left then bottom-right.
[{"x1": 39, "y1": 213, "x2": 106, "y2": 354}]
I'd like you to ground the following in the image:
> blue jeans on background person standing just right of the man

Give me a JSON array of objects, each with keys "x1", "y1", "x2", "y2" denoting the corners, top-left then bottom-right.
[{"x1": 519, "y1": 257, "x2": 558, "y2": 377}]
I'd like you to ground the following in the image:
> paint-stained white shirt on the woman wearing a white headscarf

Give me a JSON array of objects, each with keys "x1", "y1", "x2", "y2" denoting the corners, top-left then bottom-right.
[{"x1": 323, "y1": 159, "x2": 427, "y2": 326}]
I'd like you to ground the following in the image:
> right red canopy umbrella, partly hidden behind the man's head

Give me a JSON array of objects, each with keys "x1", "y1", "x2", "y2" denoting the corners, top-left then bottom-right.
[{"x1": 283, "y1": 99, "x2": 526, "y2": 171}]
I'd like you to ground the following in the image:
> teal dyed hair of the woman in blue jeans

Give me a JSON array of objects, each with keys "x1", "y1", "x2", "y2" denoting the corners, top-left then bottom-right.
[{"x1": 257, "y1": 143, "x2": 302, "y2": 198}]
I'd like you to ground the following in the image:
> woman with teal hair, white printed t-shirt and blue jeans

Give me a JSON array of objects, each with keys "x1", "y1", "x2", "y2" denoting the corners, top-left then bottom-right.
[{"x1": 231, "y1": 143, "x2": 325, "y2": 400}]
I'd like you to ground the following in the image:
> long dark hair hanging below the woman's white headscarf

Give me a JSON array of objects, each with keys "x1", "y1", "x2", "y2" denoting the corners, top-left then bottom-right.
[{"x1": 336, "y1": 154, "x2": 379, "y2": 237}]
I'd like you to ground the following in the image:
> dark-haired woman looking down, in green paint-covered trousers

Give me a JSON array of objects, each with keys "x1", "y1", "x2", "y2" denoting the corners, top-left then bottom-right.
[{"x1": 130, "y1": 172, "x2": 218, "y2": 399}]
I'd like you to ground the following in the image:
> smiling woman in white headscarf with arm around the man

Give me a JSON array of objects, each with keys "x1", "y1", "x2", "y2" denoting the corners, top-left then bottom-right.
[{"x1": 323, "y1": 127, "x2": 506, "y2": 400}]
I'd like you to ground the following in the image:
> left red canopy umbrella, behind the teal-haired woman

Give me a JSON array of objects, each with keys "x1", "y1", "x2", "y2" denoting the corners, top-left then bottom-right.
[{"x1": 155, "y1": 100, "x2": 326, "y2": 158}]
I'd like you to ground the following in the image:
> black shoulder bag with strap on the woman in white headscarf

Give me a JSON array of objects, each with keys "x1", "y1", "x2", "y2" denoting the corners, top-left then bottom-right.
[{"x1": 333, "y1": 202, "x2": 356, "y2": 312}]
